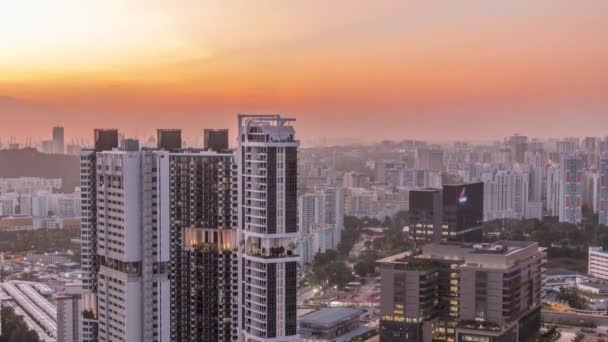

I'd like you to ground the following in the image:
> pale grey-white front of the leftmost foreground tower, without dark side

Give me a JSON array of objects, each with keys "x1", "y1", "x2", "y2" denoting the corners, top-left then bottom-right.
[{"x1": 89, "y1": 149, "x2": 170, "y2": 342}]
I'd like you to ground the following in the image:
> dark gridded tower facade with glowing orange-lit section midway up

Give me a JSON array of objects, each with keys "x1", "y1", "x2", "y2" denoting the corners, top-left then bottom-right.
[{"x1": 170, "y1": 151, "x2": 238, "y2": 341}]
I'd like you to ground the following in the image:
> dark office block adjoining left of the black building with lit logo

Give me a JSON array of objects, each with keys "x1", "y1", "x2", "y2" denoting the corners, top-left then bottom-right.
[{"x1": 405, "y1": 189, "x2": 443, "y2": 244}]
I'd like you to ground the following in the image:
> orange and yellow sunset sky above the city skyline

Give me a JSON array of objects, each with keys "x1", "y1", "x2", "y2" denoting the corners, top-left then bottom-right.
[{"x1": 0, "y1": 0, "x2": 608, "y2": 143}]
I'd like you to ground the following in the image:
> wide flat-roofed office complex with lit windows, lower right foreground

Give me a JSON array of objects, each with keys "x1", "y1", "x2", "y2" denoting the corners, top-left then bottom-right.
[{"x1": 379, "y1": 241, "x2": 546, "y2": 342}]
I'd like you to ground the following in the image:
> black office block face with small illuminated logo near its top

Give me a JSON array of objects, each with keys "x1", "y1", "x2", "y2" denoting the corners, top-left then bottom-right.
[{"x1": 442, "y1": 182, "x2": 484, "y2": 241}]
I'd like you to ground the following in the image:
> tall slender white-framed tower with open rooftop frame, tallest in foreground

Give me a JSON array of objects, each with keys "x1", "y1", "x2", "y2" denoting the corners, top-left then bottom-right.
[{"x1": 237, "y1": 114, "x2": 299, "y2": 341}]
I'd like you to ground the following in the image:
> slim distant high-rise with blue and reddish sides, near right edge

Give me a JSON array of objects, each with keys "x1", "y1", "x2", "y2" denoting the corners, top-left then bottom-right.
[{"x1": 559, "y1": 154, "x2": 583, "y2": 224}]
